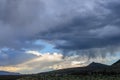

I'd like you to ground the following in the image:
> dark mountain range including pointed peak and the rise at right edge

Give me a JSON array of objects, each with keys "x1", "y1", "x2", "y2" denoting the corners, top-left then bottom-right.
[{"x1": 39, "y1": 60, "x2": 120, "y2": 75}]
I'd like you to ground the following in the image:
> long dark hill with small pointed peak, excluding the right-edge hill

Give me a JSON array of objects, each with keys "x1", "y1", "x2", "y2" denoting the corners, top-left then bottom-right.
[{"x1": 39, "y1": 62, "x2": 109, "y2": 75}]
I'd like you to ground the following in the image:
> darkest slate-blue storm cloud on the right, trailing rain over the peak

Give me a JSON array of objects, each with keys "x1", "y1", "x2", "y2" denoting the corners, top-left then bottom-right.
[{"x1": 38, "y1": 0, "x2": 120, "y2": 57}]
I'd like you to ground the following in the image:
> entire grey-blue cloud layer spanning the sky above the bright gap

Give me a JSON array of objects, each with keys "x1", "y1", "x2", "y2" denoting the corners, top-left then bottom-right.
[{"x1": 0, "y1": 0, "x2": 120, "y2": 56}]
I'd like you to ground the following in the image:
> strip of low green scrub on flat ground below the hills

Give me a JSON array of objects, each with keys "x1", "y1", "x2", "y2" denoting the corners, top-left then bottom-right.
[{"x1": 17, "y1": 75, "x2": 120, "y2": 80}]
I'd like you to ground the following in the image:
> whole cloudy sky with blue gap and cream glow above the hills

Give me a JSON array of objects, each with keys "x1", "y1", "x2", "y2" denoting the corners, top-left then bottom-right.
[{"x1": 0, "y1": 0, "x2": 120, "y2": 74}]
